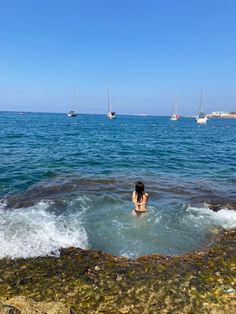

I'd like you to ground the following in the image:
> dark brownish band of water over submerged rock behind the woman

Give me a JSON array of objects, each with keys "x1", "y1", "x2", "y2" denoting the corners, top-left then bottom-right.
[{"x1": 2, "y1": 171, "x2": 235, "y2": 213}]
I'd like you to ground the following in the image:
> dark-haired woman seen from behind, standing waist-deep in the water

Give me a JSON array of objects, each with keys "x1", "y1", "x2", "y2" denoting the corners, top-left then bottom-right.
[{"x1": 132, "y1": 181, "x2": 148, "y2": 214}]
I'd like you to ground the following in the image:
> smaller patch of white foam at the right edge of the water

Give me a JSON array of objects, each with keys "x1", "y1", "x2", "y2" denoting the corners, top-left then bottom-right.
[{"x1": 187, "y1": 207, "x2": 236, "y2": 229}]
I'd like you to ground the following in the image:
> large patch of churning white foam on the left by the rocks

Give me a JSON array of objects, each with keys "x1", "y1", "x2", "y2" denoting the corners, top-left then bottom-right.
[{"x1": 0, "y1": 201, "x2": 87, "y2": 258}]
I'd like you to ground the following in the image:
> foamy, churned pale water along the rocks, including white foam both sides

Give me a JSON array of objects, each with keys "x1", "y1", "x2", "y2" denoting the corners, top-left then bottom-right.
[{"x1": 0, "y1": 196, "x2": 236, "y2": 258}]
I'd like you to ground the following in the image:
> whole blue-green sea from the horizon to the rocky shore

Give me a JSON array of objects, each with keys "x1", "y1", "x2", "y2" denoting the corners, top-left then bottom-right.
[{"x1": 0, "y1": 112, "x2": 236, "y2": 258}]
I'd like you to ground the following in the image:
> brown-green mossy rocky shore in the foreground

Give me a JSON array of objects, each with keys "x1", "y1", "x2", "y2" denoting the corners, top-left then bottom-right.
[{"x1": 0, "y1": 229, "x2": 236, "y2": 314}]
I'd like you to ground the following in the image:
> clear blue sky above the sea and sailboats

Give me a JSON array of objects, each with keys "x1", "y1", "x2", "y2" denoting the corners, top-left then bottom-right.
[{"x1": 0, "y1": 0, "x2": 236, "y2": 115}]
